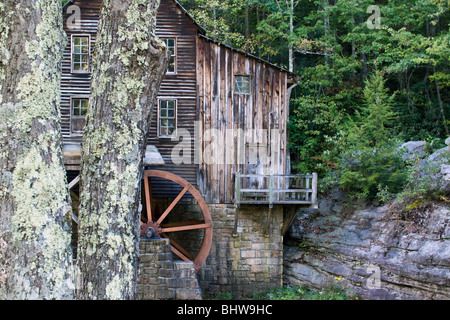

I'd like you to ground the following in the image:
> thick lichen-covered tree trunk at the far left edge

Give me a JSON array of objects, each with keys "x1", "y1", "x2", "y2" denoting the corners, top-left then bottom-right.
[{"x1": 0, "y1": 0, "x2": 75, "y2": 299}]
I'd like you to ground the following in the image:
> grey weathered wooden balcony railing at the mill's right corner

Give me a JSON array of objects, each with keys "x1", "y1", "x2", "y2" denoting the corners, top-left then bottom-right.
[{"x1": 235, "y1": 172, "x2": 318, "y2": 207}]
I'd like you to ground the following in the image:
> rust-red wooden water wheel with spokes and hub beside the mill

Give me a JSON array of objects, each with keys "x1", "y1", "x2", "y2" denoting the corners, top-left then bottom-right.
[{"x1": 141, "y1": 170, "x2": 213, "y2": 270}]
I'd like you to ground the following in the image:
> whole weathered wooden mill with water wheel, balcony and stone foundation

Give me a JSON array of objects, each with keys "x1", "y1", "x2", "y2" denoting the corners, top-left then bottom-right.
[{"x1": 61, "y1": 0, "x2": 317, "y2": 295}]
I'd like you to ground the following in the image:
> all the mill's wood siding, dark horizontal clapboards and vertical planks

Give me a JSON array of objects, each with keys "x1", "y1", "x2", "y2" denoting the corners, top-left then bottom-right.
[{"x1": 61, "y1": 0, "x2": 288, "y2": 203}]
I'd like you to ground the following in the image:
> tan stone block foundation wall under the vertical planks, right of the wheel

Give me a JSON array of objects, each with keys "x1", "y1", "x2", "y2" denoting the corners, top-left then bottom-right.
[{"x1": 198, "y1": 204, "x2": 283, "y2": 298}]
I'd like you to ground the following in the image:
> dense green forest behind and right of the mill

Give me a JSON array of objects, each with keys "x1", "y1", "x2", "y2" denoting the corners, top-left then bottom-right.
[{"x1": 180, "y1": 0, "x2": 450, "y2": 199}]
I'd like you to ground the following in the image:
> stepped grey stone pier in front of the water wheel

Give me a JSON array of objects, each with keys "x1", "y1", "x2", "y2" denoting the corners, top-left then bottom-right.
[{"x1": 138, "y1": 239, "x2": 202, "y2": 300}]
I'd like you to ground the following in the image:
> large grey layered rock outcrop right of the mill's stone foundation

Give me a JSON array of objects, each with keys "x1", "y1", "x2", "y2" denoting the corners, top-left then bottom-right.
[{"x1": 284, "y1": 194, "x2": 450, "y2": 300}]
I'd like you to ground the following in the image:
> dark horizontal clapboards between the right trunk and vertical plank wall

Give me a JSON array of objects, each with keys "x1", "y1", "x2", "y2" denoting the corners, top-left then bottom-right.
[{"x1": 148, "y1": 0, "x2": 198, "y2": 197}]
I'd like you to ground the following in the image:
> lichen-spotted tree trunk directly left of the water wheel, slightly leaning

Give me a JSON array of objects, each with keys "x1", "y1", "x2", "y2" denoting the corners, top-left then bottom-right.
[{"x1": 77, "y1": 0, "x2": 168, "y2": 300}]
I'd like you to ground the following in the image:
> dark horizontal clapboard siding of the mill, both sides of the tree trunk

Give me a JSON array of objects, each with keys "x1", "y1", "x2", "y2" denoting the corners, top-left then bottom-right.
[{"x1": 61, "y1": 0, "x2": 201, "y2": 197}]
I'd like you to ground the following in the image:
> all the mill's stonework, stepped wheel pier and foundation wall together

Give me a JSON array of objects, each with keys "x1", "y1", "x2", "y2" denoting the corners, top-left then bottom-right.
[{"x1": 139, "y1": 199, "x2": 283, "y2": 299}]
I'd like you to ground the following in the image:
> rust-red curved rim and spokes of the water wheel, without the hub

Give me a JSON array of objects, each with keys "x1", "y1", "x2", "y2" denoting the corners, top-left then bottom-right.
[{"x1": 144, "y1": 170, "x2": 213, "y2": 271}]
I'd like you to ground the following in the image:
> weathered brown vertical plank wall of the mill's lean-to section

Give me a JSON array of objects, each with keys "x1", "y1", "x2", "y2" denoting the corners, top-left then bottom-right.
[{"x1": 197, "y1": 36, "x2": 287, "y2": 203}]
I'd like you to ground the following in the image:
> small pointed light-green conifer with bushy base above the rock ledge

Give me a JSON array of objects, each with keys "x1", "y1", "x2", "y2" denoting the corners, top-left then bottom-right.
[{"x1": 339, "y1": 71, "x2": 406, "y2": 199}]
